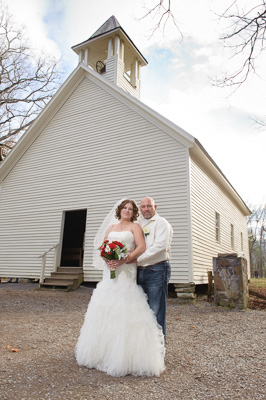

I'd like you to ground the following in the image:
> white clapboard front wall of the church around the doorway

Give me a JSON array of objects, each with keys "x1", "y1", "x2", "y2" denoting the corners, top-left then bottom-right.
[{"x1": 0, "y1": 78, "x2": 189, "y2": 282}]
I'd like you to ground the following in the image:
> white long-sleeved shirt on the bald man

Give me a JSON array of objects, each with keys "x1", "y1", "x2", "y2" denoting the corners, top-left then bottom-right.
[{"x1": 137, "y1": 213, "x2": 173, "y2": 267}]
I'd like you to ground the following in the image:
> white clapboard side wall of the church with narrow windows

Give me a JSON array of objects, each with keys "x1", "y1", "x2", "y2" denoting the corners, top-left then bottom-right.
[{"x1": 191, "y1": 160, "x2": 249, "y2": 284}]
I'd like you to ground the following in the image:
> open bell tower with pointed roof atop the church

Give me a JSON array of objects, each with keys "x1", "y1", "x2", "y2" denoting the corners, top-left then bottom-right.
[{"x1": 72, "y1": 16, "x2": 148, "y2": 99}]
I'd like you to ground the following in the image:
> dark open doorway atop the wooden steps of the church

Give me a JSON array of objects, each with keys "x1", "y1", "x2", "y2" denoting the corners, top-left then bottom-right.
[{"x1": 60, "y1": 210, "x2": 87, "y2": 267}]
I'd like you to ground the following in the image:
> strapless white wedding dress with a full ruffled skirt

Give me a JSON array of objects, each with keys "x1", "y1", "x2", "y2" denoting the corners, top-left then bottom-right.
[{"x1": 76, "y1": 231, "x2": 165, "y2": 376}]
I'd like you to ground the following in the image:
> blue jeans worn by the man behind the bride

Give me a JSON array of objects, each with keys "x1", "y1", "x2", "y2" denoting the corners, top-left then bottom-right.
[{"x1": 137, "y1": 261, "x2": 171, "y2": 336}]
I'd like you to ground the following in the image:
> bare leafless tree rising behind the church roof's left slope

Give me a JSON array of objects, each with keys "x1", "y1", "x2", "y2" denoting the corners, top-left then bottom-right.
[{"x1": 0, "y1": 4, "x2": 60, "y2": 162}]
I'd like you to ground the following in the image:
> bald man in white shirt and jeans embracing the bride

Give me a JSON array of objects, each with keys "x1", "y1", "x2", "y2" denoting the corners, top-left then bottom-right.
[{"x1": 137, "y1": 197, "x2": 173, "y2": 336}]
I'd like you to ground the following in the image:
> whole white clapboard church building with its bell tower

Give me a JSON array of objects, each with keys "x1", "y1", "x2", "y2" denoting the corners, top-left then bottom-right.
[{"x1": 0, "y1": 16, "x2": 250, "y2": 285}]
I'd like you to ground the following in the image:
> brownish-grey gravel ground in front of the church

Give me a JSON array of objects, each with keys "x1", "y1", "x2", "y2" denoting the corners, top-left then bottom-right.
[{"x1": 0, "y1": 283, "x2": 266, "y2": 400}]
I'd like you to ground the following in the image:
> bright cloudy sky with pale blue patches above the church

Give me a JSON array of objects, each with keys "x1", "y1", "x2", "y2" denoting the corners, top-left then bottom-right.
[{"x1": 2, "y1": 0, "x2": 266, "y2": 208}]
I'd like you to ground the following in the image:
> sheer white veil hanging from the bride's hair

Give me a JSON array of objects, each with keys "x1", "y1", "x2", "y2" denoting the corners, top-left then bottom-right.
[{"x1": 92, "y1": 198, "x2": 126, "y2": 270}]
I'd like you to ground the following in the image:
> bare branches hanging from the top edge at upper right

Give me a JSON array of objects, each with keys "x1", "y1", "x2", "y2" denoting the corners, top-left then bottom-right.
[{"x1": 142, "y1": 0, "x2": 266, "y2": 88}]
